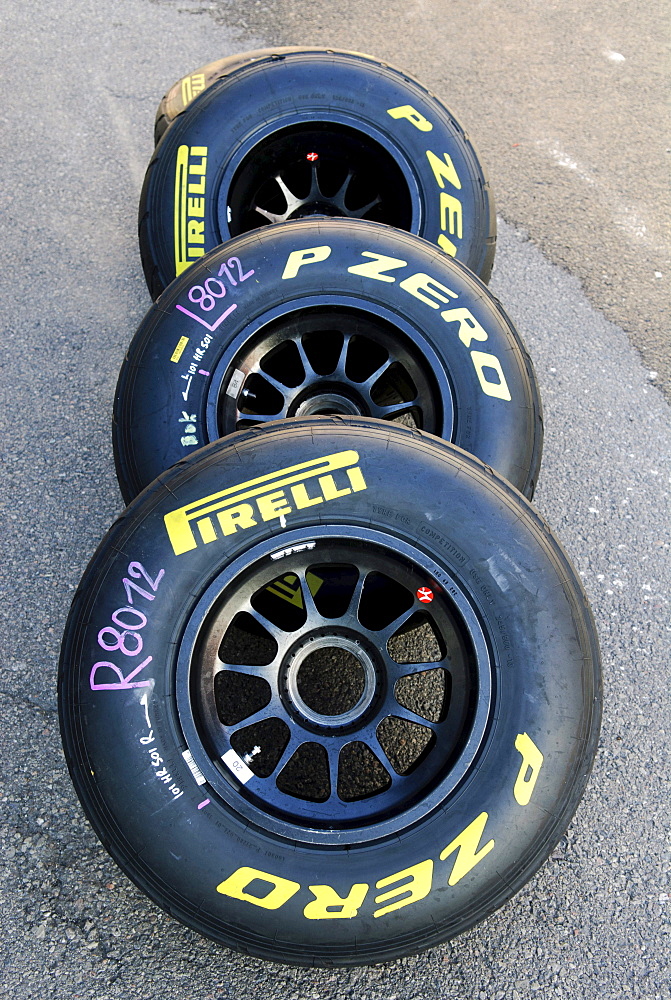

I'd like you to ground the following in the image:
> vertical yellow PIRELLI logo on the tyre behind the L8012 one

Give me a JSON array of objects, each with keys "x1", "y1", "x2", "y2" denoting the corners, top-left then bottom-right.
[{"x1": 174, "y1": 146, "x2": 207, "y2": 274}]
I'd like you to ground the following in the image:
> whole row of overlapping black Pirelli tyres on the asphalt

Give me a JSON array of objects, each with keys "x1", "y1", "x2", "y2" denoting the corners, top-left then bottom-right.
[{"x1": 59, "y1": 49, "x2": 601, "y2": 965}]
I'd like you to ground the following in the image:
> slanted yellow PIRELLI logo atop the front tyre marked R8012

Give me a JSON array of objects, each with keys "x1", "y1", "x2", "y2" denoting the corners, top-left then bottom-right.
[{"x1": 164, "y1": 451, "x2": 366, "y2": 556}]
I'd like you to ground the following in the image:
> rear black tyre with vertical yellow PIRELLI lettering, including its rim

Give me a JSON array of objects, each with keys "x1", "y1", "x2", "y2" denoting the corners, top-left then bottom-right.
[{"x1": 139, "y1": 50, "x2": 496, "y2": 298}]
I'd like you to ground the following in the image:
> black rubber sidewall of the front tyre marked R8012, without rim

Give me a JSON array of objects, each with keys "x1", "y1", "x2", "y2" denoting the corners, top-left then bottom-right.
[{"x1": 60, "y1": 418, "x2": 599, "y2": 964}]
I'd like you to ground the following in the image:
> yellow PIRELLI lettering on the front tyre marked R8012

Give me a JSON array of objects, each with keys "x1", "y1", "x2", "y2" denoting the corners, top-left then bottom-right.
[{"x1": 164, "y1": 450, "x2": 366, "y2": 555}]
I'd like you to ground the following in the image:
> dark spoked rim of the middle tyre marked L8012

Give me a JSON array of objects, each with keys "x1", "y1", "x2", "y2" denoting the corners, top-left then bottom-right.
[{"x1": 208, "y1": 305, "x2": 453, "y2": 438}]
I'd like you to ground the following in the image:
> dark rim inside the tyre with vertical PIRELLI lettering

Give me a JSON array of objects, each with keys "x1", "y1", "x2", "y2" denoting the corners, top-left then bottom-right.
[{"x1": 227, "y1": 121, "x2": 413, "y2": 236}]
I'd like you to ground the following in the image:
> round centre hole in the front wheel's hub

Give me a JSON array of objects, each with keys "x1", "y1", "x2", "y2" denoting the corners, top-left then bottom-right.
[{"x1": 296, "y1": 646, "x2": 365, "y2": 716}]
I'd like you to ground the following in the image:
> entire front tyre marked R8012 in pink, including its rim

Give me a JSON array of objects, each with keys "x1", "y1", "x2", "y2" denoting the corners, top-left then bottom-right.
[{"x1": 59, "y1": 417, "x2": 600, "y2": 965}]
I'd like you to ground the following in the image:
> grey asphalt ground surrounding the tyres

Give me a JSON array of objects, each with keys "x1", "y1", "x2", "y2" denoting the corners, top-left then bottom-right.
[{"x1": 0, "y1": 0, "x2": 671, "y2": 1000}]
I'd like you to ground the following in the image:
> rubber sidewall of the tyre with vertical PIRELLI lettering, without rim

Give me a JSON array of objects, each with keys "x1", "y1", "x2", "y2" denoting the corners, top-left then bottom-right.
[{"x1": 140, "y1": 53, "x2": 495, "y2": 288}]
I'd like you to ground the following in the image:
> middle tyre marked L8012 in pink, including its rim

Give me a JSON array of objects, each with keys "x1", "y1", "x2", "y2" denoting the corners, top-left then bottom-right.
[{"x1": 114, "y1": 219, "x2": 542, "y2": 502}]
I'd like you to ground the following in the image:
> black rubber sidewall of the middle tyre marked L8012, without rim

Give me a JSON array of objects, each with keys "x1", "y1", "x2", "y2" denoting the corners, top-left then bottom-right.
[{"x1": 114, "y1": 219, "x2": 542, "y2": 502}]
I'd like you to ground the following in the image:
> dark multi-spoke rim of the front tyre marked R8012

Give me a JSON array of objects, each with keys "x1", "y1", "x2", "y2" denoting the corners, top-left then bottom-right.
[{"x1": 177, "y1": 528, "x2": 491, "y2": 844}]
